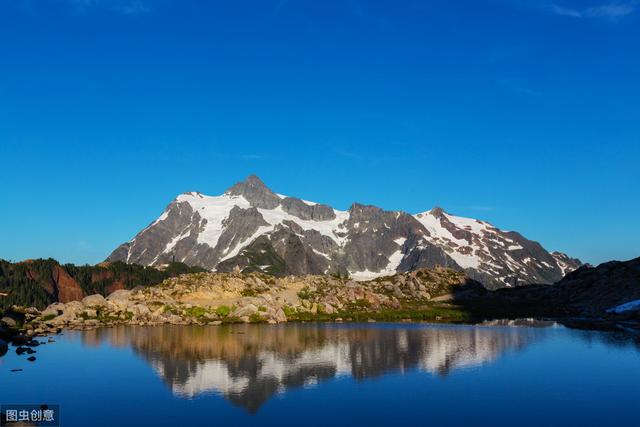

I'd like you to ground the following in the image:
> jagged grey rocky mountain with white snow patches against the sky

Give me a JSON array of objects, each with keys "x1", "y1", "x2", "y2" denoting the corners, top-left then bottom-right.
[{"x1": 107, "y1": 175, "x2": 581, "y2": 289}]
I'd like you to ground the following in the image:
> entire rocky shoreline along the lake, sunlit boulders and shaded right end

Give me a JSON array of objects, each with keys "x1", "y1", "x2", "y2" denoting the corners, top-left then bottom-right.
[{"x1": 0, "y1": 268, "x2": 640, "y2": 354}]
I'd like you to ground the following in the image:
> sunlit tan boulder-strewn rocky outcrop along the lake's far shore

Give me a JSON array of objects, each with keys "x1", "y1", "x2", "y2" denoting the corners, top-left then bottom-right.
[{"x1": 27, "y1": 269, "x2": 486, "y2": 335}]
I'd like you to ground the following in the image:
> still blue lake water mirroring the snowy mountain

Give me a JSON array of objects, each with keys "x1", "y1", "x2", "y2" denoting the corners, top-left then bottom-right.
[{"x1": 0, "y1": 324, "x2": 640, "y2": 427}]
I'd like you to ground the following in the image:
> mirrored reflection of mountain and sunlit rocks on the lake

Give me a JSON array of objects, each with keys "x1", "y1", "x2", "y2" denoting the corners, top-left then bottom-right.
[{"x1": 83, "y1": 324, "x2": 544, "y2": 413}]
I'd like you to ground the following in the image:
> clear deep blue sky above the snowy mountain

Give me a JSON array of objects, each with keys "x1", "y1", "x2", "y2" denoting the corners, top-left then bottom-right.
[{"x1": 0, "y1": 0, "x2": 640, "y2": 263}]
